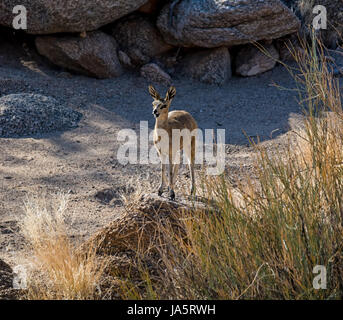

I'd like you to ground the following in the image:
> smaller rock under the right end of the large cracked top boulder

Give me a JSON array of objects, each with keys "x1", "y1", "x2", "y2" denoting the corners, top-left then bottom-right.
[{"x1": 235, "y1": 45, "x2": 279, "y2": 77}]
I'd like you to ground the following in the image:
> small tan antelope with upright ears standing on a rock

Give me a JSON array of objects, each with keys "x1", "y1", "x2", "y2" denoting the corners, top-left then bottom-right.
[{"x1": 149, "y1": 86, "x2": 198, "y2": 200}]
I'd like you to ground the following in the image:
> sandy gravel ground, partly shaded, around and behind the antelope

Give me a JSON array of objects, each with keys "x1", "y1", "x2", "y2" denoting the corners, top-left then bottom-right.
[{"x1": 0, "y1": 33, "x2": 301, "y2": 265}]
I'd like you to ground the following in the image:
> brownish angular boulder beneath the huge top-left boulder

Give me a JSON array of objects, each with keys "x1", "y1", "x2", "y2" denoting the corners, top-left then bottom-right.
[{"x1": 36, "y1": 31, "x2": 123, "y2": 78}]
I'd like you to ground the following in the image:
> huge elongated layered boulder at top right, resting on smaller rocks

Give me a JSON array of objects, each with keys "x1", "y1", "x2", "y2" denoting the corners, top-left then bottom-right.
[{"x1": 157, "y1": 0, "x2": 300, "y2": 48}]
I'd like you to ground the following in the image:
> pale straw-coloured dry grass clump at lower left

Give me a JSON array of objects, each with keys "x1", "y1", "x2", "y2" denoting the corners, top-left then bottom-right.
[{"x1": 21, "y1": 195, "x2": 105, "y2": 300}]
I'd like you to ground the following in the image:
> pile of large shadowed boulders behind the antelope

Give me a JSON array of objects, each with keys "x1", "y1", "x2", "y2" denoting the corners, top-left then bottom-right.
[{"x1": 4, "y1": 0, "x2": 341, "y2": 85}]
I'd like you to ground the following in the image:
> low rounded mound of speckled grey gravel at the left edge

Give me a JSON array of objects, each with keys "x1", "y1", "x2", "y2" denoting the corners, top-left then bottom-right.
[{"x1": 0, "y1": 93, "x2": 81, "y2": 138}]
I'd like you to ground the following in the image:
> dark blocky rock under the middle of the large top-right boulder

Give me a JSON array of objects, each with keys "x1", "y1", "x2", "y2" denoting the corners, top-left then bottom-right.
[{"x1": 181, "y1": 47, "x2": 232, "y2": 85}]
